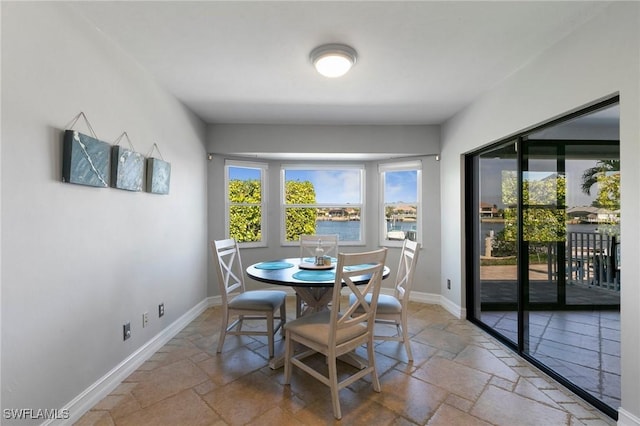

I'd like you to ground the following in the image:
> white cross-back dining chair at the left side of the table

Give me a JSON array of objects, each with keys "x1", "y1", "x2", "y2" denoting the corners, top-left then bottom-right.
[{"x1": 211, "y1": 239, "x2": 287, "y2": 358}]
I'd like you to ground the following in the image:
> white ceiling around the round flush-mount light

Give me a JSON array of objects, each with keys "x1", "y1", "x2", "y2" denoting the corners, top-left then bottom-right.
[{"x1": 69, "y1": 1, "x2": 607, "y2": 124}]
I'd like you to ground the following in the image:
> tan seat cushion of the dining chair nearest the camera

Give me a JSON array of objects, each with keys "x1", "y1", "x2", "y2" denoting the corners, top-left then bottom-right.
[{"x1": 284, "y1": 311, "x2": 367, "y2": 345}]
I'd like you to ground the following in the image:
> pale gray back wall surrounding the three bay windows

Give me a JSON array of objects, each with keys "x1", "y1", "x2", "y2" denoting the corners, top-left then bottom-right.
[{"x1": 208, "y1": 124, "x2": 440, "y2": 295}]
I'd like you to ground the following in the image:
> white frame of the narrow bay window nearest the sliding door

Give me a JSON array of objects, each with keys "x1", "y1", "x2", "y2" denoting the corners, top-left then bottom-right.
[{"x1": 378, "y1": 160, "x2": 423, "y2": 247}]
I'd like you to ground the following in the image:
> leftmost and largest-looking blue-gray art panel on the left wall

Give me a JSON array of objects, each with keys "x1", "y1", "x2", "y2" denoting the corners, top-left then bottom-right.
[{"x1": 62, "y1": 130, "x2": 111, "y2": 188}]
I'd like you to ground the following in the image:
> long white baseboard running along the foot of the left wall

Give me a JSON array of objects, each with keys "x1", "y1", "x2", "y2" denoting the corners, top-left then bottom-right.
[{"x1": 51, "y1": 299, "x2": 211, "y2": 426}]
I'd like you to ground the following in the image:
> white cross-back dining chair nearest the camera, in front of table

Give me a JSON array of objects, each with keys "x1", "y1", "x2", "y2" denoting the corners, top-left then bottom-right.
[{"x1": 284, "y1": 248, "x2": 387, "y2": 419}]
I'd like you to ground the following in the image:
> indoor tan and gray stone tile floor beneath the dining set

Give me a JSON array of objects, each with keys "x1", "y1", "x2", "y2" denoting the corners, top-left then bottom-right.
[{"x1": 76, "y1": 298, "x2": 615, "y2": 426}]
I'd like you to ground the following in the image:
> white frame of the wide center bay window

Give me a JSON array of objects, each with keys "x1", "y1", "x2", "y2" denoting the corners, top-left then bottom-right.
[{"x1": 280, "y1": 163, "x2": 366, "y2": 246}]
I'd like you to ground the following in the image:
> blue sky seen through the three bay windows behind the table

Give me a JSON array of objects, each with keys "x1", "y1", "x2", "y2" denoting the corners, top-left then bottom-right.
[{"x1": 229, "y1": 167, "x2": 417, "y2": 205}]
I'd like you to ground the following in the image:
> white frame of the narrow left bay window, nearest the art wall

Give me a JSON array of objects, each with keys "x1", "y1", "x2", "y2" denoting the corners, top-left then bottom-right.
[{"x1": 224, "y1": 159, "x2": 269, "y2": 248}]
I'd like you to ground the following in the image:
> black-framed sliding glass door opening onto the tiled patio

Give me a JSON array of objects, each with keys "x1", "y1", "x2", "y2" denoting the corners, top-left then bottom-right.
[{"x1": 466, "y1": 98, "x2": 622, "y2": 417}]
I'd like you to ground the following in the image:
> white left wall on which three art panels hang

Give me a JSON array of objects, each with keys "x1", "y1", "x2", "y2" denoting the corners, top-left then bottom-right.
[{"x1": 1, "y1": 2, "x2": 208, "y2": 424}]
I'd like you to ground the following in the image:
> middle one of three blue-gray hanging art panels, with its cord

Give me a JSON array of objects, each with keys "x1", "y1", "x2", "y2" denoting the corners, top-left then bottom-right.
[{"x1": 111, "y1": 132, "x2": 144, "y2": 191}]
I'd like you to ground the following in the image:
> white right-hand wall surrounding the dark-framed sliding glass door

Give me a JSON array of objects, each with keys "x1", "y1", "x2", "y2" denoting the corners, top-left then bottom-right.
[{"x1": 440, "y1": 2, "x2": 640, "y2": 424}]
